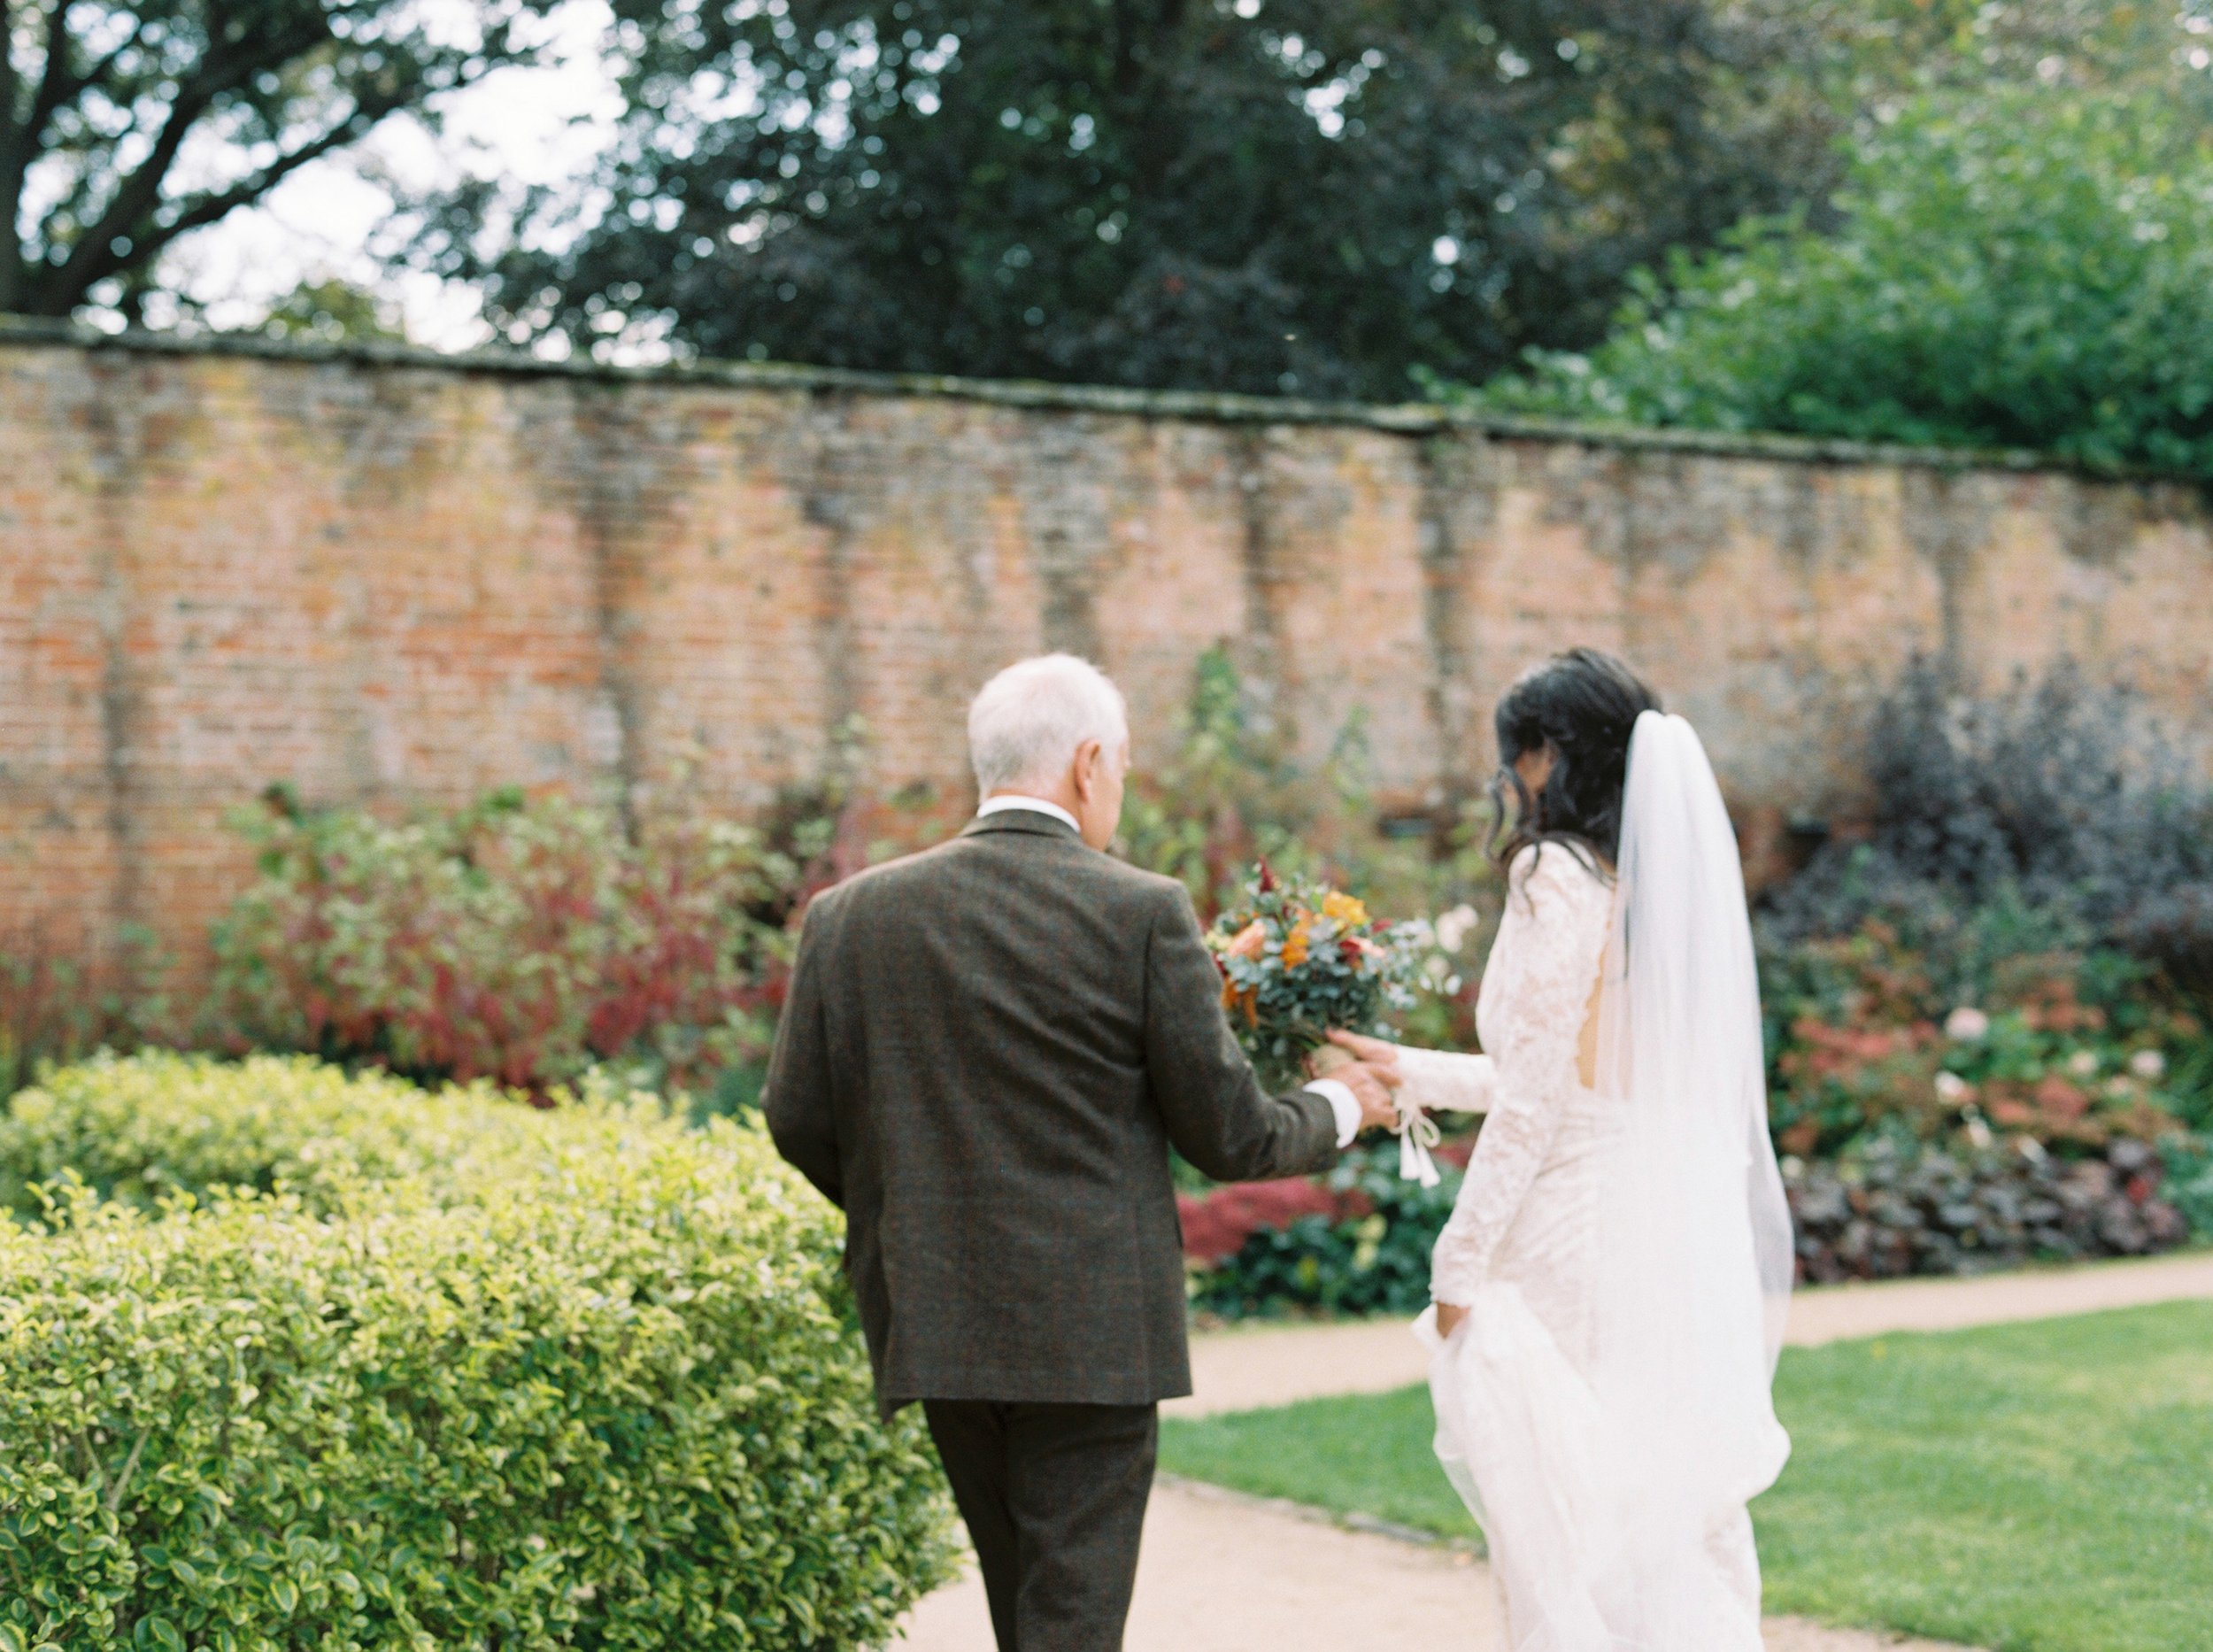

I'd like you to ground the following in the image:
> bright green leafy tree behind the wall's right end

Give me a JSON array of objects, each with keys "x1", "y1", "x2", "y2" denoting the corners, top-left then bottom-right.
[{"x1": 1478, "y1": 87, "x2": 2213, "y2": 476}]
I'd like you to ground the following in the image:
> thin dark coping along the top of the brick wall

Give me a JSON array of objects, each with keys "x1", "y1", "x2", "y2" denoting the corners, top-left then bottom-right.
[{"x1": 0, "y1": 314, "x2": 2124, "y2": 481}]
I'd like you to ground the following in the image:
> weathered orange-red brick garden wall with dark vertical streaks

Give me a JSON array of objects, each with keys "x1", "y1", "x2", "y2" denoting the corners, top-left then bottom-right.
[{"x1": 0, "y1": 328, "x2": 2213, "y2": 983}]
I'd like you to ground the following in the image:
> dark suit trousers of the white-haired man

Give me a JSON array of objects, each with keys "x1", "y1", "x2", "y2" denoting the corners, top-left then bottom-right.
[{"x1": 923, "y1": 1400, "x2": 1160, "y2": 1652}]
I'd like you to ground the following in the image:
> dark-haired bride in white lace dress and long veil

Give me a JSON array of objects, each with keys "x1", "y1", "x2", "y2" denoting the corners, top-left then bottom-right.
[{"x1": 1335, "y1": 649, "x2": 1793, "y2": 1652}]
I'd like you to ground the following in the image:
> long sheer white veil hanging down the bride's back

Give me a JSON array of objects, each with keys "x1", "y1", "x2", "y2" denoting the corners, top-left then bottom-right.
[{"x1": 1592, "y1": 711, "x2": 1795, "y2": 1652}]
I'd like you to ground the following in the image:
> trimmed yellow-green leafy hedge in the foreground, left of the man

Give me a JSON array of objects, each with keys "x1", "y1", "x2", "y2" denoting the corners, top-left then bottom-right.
[{"x1": 0, "y1": 1056, "x2": 952, "y2": 1652}]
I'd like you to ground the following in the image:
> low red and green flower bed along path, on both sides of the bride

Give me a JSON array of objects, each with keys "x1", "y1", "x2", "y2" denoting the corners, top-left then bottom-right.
[{"x1": 1184, "y1": 919, "x2": 2213, "y2": 1317}]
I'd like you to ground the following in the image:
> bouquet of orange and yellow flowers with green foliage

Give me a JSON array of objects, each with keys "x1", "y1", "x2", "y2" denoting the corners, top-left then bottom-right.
[{"x1": 1207, "y1": 861, "x2": 1434, "y2": 1087}]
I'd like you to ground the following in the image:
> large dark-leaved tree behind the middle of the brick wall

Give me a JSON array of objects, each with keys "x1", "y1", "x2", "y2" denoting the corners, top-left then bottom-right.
[{"x1": 423, "y1": 0, "x2": 1826, "y2": 397}]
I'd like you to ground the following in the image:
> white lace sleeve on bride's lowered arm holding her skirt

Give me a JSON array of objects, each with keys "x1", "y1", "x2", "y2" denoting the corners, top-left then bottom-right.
[{"x1": 1430, "y1": 844, "x2": 1614, "y2": 1307}]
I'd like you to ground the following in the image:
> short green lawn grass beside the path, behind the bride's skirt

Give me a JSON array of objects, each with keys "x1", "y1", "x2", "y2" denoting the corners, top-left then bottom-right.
[{"x1": 1162, "y1": 1302, "x2": 2213, "y2": 1652}]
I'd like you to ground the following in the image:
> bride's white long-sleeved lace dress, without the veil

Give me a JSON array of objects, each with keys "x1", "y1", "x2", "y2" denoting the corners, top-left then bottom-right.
[{"x1": 1399, "y1": 775, "x2": 1786, "y2": 1652}]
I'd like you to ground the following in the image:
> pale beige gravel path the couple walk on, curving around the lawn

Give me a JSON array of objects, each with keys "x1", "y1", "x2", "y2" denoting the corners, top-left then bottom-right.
[{"x1": 898, "y1": 1254, "x2": 2213, "y2": 1652}]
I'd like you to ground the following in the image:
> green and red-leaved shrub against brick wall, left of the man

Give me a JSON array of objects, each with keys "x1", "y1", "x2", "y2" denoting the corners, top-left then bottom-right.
[{"x1": 212, "y1": 791, "x2": 797, "y2": 1096}]
